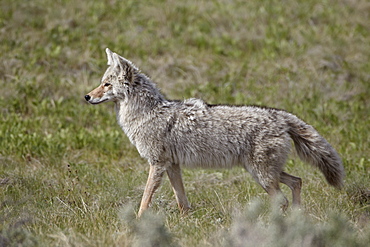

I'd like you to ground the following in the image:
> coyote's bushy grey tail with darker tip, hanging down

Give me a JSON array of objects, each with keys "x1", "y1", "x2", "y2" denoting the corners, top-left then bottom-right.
[{"x1": 287, "y1": 114, "x2": 344, "y2": 189}]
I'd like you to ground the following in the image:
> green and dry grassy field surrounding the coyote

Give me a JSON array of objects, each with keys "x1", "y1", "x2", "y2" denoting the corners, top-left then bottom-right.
[{"x1": 0, "y1": 0, "x2": 370, "y2": 246}]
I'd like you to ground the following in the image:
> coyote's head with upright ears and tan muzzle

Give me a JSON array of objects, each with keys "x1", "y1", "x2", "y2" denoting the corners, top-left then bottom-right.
[{"x1": 85, "y1": 48, "x2": 140, "y2": 104}]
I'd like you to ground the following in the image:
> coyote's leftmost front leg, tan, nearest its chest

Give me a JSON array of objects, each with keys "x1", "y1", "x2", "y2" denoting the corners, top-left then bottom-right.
[{"x1": 138, "y1": 164, "x2": 165, "y2": 217}]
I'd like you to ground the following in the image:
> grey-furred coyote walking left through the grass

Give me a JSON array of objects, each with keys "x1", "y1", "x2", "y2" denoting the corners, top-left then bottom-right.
[{"x1": 85, "y1": 48, "x2": 344, "y2": 217}]
